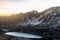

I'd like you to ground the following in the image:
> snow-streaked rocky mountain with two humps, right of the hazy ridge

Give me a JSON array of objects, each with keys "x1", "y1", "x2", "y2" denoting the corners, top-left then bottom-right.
[{"x1": 14, "y1": 7, "x2": 60, "y2": 29}]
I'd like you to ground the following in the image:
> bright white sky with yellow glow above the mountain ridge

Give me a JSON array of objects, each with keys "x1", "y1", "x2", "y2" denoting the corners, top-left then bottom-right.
[{"x1": 0, "y1": 0, "x2": 60, "y2": 15}]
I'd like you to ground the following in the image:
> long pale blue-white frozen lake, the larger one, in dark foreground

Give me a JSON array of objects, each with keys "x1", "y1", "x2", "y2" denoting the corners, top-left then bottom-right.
[{"x1": 5, "y1": 32, "x2": 43, "y2": 39}]
